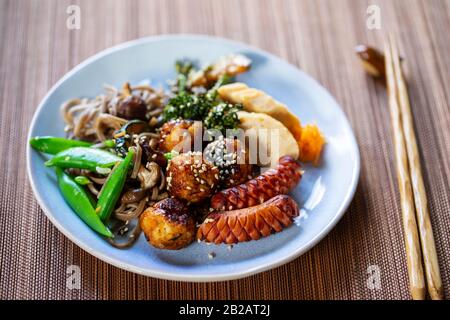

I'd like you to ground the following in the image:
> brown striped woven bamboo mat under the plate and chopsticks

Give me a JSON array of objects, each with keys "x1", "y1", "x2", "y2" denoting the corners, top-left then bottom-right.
[{"x1": 0, "y1": 0, "x2": 450, "y2": 299}]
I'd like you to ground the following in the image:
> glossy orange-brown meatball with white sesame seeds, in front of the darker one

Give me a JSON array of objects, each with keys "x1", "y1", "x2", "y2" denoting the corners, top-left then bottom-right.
[{"x1": 166, "y1": 152, "x2": 219, "y2": 203}]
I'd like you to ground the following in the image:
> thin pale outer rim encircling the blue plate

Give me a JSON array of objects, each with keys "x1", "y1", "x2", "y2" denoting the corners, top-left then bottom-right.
[{"x1": 26, "y1": 33, "x2": 360, "y2": 282}]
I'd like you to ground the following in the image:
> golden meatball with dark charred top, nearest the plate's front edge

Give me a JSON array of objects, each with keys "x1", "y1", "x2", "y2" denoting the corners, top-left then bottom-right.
[{"x1": 139, "y1": 198, "x2": 195, "y2": 250}]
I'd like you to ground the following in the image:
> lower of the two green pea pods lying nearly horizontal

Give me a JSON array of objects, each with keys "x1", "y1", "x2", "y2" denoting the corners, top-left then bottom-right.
[{"x1": 45, "y1": 147, "x2": 122, "y2": 174}]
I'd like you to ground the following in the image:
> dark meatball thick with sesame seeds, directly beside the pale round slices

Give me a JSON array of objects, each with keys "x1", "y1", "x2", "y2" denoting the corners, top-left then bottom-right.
[{"x1": 205, "y1": 138, "x2": 254, "y2": 188}]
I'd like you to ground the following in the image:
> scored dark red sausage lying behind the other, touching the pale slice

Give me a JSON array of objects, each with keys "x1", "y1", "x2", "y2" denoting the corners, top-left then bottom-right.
[{"x1": 211, "y1": 156, "x2": 301, "y2": 211}]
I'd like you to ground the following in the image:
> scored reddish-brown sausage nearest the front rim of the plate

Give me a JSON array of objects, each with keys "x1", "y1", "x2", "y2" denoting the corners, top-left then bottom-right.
[{"x1": 197, "y1": 195, "x2": 299, "y2": 244}]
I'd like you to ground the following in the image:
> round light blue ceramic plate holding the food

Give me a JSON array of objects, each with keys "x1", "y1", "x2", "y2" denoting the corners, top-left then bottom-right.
[{"x1": 27, "y1": 35, "x2": 360, "y2": 281}]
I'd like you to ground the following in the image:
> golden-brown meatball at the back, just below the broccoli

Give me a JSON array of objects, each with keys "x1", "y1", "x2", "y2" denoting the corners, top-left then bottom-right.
[{"x1": 159, "y1": 120, "x2": 203, "y2": 152}]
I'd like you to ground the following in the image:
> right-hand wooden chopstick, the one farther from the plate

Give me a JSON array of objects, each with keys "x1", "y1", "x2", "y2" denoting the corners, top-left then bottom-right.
[{"x1": 389, "y1": 35, "x2": 444, "y2": 300}]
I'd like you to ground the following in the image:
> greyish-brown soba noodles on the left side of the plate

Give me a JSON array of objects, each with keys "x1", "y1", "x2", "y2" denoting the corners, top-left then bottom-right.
[{"x1": 61, "y1": 83, "x2": 168, "y2": 248}]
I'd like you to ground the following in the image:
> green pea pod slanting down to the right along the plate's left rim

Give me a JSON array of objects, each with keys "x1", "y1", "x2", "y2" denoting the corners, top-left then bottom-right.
[{"x1": 56, "y1": 167, "x2": 114, "y2": 238}]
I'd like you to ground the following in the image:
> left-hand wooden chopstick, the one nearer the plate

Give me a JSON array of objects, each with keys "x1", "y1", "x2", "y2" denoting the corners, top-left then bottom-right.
[{"x1": 384, "y1": 37, "x2": 425, "y2": 300}]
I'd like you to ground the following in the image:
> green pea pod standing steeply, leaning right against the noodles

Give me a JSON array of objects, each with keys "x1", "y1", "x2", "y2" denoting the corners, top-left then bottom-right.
[{"x1": 95, "y1": 150, "x2": 135, "y2": 221}]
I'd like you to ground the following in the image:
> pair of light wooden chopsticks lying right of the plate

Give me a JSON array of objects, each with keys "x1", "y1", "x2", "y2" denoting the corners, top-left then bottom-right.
[{"x1": 384, "y1": 35, "x2": 443, "y2": 300}]
